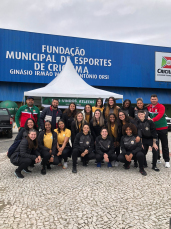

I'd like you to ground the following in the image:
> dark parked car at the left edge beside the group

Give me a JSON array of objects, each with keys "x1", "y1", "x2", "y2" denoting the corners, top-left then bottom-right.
[{"x1": 0, "y1": 108, "x2": 13, "y2": 138}]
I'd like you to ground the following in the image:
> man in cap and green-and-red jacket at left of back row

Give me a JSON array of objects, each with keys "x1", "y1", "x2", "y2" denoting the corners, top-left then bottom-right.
[{"x1": 15, "y1": 96, "x2": 40, "y2": 130}]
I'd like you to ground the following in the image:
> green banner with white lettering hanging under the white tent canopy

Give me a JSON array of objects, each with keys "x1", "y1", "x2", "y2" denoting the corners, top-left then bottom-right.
[{"x1": 42, "y1": 98, "x2": 96, "y2": 107}]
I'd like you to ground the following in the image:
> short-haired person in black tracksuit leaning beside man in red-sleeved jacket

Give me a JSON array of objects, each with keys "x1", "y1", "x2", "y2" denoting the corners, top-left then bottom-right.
[{"x1": 137, "y1": 110, "x2": 160, "y2": 172}]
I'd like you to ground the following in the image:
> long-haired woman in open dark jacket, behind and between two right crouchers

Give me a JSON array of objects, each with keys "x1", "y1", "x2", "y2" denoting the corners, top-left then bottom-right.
[{"x1": 107, "y1": 113, "x2": 120, "y2": 166}]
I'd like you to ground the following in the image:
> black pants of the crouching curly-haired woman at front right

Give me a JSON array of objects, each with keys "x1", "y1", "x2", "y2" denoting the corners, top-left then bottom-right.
[{"x1": 118, "y1": 151, "x2": 144, "y2": 169}]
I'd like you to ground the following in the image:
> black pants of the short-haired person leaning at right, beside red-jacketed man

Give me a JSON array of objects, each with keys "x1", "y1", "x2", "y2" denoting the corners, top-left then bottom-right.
[{"x1": 142, "y1": 138, "x2": 159, "y2": 167}]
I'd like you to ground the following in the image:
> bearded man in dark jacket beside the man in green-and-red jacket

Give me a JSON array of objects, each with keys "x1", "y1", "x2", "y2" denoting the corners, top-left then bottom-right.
[{"x1": 40, "y1": 99, "x2": 62, "y2": 130}]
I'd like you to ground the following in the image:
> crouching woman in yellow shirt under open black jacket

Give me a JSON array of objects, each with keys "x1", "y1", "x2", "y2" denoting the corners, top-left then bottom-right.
[{"x1": 38, "y1": 120, "x2": 59, "y2": 175}]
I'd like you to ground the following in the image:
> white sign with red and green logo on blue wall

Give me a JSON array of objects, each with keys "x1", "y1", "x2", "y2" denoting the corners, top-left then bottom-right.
[{"x1": 155, "y1": 52, "x2": 171, "y2": 82}]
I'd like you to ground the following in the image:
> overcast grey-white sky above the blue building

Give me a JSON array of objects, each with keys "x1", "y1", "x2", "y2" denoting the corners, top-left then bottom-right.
[{"x1": 0, "y1": 0, "x2": 171, "y2": 47}]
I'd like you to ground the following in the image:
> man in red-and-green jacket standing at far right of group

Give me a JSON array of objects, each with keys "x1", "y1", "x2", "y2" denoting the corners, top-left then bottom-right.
[{"x1": 147, "y1": 94, "x2": 170, "y2": 168}]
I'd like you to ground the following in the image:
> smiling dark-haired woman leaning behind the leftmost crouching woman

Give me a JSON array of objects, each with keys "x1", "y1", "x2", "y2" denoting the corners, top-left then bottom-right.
[{"x1": 7, "y1": 118, "x2": 39, "y2": 158}]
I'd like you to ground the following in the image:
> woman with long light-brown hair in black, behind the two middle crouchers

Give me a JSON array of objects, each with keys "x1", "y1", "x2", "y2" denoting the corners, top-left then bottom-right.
[{"x1": 90, "y1": 109, "x2": 104, "y2": 141}]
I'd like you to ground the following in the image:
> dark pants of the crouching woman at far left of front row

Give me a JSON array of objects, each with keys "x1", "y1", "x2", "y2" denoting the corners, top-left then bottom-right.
[{"x1": 11, "y1": 157, "x2": 35, "y2": 172}]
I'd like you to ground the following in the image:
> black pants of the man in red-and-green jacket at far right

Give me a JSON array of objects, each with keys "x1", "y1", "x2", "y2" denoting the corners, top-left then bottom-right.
[{"x1": 156, "y1": 129, "x2": 170, "y2": 162}]
